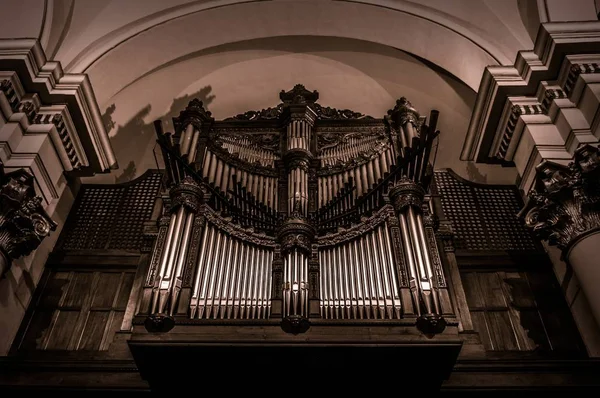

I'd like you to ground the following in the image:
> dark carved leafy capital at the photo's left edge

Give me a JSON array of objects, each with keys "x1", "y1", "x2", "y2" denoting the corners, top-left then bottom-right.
[{"x1": 0, "y1": 162, "x2": 57, "y2": 276}]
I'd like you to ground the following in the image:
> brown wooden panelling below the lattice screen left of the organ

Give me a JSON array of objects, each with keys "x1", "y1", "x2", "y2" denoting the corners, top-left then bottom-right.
[{"x1": 18, "y1": 269, "x2": 135, "y2": 350}]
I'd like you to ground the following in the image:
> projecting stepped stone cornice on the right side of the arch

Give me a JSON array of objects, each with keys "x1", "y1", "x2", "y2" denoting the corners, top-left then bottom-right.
[{"x1": 460, "y1": 21, "x2": 600, "y2": 163}]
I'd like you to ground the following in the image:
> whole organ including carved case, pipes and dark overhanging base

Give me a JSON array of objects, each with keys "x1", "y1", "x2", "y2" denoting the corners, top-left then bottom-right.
[{"x1": 129, "y1": 85, "x2": 461, "y2": 390}]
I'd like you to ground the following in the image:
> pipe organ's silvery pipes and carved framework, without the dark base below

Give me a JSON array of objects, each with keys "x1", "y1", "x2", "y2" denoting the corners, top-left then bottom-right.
[{"x1": 139, "y1": 85, "x2": 453, "y2": 334}]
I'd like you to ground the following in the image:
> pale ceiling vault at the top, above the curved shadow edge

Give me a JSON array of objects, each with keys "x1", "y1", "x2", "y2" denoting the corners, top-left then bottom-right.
[{"x1": 48, "y1": 0, "x2": 532, "y2": 89}]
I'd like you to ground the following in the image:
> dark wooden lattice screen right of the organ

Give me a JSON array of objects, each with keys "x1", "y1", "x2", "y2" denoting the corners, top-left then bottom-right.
[{"x1": 435, "y1": 170, "x2": 536, "y2": 251}]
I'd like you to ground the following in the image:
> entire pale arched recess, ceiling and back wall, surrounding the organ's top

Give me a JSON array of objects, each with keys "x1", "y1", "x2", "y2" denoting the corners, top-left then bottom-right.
[{"x1": 36, "y1": 0, "x2": 544, "y2": 183}]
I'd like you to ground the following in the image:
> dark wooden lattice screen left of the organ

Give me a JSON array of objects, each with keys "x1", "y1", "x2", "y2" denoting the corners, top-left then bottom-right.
[{"x1": 61, "y1": 171, "x2": 162, "y2": 250}]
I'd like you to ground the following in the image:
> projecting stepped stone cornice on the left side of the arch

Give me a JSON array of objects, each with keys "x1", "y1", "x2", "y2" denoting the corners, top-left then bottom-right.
[{"x1": 0, "y1": 39, "x2": 117, "y2": 175}]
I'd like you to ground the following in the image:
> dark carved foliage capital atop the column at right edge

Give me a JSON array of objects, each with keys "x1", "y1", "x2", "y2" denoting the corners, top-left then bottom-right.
[{"x1": 519, "y1": 144, "x2": 600, "y2": 250}]
